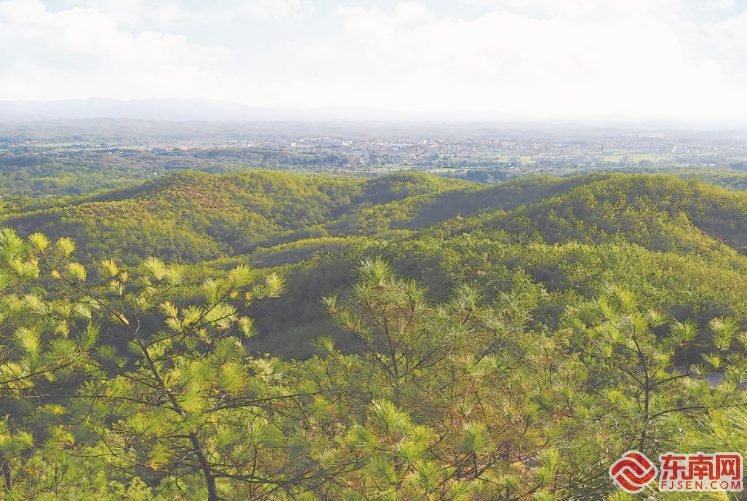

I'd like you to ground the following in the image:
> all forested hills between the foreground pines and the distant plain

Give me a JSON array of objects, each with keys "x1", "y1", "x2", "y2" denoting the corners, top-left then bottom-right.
[{"x1": 2, "y1": 172, "x2": 747, "y2": 358}]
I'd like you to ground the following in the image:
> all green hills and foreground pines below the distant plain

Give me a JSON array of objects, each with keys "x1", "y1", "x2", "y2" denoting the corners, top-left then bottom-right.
[{"x1": 0, "y1": 171, "x2": 747, "y2": 501}]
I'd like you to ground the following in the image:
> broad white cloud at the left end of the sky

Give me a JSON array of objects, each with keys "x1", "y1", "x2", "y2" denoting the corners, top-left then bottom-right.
[{"x1": 0, "y1": 0, "x2": 232, "y2": 99}]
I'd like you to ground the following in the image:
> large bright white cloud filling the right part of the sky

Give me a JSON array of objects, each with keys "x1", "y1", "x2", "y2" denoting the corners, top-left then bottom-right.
[{"x1": 284, "y1": 0, "x2": 742, "y2": 116}]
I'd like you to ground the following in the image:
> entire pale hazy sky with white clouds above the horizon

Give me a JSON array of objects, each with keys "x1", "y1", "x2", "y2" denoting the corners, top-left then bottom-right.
[{"x1": 0, "y1": 0, "x2": 747, "y2": 119}]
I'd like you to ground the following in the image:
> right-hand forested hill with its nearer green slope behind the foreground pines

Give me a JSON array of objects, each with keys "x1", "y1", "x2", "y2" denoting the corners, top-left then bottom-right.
[{"x1": 245, "y1": 175, "x2": 747, "y2": 356}]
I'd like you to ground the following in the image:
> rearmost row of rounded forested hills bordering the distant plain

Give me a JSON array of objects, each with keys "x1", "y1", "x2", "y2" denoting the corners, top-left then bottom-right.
[{"x1": 0, "y1": 172, "x2": 747, "y2": 262}]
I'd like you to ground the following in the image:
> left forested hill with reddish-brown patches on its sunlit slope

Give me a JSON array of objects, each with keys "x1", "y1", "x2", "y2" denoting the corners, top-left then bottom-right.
[{"x1": 2, "y1": 172, "x2": 466, "y2": 262}]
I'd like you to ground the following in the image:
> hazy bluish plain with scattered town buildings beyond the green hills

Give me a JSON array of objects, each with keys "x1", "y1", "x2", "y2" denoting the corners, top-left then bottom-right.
[{"x1": 0, "y1": 121, "x2": 747, "y2": 188}]
